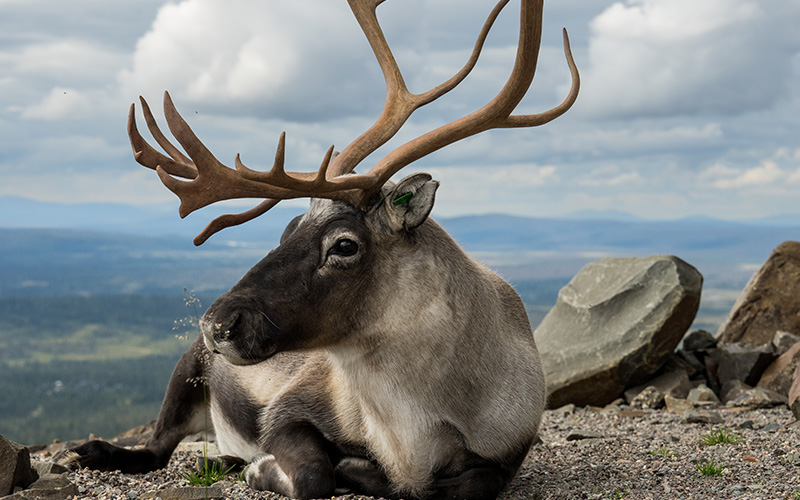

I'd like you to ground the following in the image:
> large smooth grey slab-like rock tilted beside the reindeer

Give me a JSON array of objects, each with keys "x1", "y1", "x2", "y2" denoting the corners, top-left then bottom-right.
[{"x1": 534, "y1": 255, "x2": 703, "y2": 408}]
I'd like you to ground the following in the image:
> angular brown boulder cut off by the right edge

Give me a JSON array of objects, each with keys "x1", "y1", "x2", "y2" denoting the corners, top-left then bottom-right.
[{"x1": 717, "y1": 241, "x2": 800, "y2": 345}]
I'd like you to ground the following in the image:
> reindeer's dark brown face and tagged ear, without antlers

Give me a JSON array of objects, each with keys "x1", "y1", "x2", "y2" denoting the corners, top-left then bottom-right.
[{"x1": 201, "y1": 174, "x2": 439, "y2": 364}]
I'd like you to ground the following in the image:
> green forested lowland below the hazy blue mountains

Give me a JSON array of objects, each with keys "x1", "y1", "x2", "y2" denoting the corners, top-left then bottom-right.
[{"x1": 0, "y1": 278, "x2": 735, "y2": 445}]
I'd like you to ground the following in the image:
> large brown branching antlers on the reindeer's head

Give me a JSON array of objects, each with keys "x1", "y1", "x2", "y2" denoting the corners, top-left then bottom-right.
[{"x1": 128, "y1": 0, "x2": 580, "y2": 245}]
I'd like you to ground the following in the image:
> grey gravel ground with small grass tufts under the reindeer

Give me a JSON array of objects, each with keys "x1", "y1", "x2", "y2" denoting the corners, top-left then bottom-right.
[{"x1": 51, "y1": 406, "x2": 800, "y2": 500}]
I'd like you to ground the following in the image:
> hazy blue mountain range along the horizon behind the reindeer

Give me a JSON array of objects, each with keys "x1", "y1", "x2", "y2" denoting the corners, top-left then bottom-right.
[{"x1": 0, "y1": 197, "x2": 800, "y2": 297}]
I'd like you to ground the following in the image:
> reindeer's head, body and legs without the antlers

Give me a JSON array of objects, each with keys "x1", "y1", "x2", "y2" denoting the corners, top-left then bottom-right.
[{"x1": 70, "y1": 181, "x2": 545, "y2": 498}]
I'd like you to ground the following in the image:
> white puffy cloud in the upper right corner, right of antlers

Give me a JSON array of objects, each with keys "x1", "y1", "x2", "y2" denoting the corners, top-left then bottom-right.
[{"x1": 582, "y1": 0, "x2": 800, "y2": 116}]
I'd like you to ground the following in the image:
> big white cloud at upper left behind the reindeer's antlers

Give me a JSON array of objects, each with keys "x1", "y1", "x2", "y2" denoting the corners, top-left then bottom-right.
[{"x1": 118, "y1": 0, "x2": 381, "y2": 119}]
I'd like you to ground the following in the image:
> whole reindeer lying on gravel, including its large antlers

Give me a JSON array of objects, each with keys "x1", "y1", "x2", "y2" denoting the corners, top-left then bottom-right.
[{"x1": 67, "y1": 0, "x2": 579, "y2": 499}]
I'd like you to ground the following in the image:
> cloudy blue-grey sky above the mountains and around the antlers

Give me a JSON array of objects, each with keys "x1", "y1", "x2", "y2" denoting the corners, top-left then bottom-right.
[{"x1": 0, "y1": 0, "x2": 800, "y2": 225}]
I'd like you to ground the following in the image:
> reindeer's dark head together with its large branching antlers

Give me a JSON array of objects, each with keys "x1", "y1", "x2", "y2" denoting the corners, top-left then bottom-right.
[{"x1": 128, "y1": 0, "x2": 580, "y2": 362}]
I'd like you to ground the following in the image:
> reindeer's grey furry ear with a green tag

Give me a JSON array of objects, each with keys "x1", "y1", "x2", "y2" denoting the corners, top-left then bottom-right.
[{"x1": 383, "y1": 174, "x2": 439, "y2": 231}]
